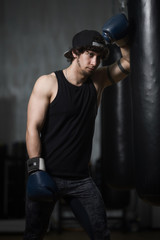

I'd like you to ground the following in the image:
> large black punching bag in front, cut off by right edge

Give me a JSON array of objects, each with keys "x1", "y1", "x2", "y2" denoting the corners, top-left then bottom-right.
[{"x1": 128, "y1": 0, "x2": 160, "y2": 205}]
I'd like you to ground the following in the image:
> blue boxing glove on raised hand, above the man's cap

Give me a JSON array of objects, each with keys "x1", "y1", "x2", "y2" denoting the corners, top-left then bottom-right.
[{"x1": 102, "y1": 13, "x2": 129, "y2": 47}]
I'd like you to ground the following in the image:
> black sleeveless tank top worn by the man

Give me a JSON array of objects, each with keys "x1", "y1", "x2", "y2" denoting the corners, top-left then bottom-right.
[{"x1": 41, "y1": 71, "x2": 97, "y2": 178}]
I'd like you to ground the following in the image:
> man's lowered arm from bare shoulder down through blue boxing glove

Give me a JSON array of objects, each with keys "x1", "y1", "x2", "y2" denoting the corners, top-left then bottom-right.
[{"x1": 26, "y1": 74, "x2": 58, "y2": 202}]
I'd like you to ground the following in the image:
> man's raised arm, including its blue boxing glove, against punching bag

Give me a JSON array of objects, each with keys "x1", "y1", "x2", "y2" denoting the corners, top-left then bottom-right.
[{"x1": 93, "y1": 14, "x2": 130, "y2": 97}]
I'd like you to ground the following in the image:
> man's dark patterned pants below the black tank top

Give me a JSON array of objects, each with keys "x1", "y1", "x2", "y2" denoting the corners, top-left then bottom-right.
[{"x1": 24, "y1": 177, "x2": 110, "y2": 240}]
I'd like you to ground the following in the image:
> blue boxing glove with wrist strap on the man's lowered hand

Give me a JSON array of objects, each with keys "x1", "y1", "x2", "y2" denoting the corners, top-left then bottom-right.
[{"x1": 27, "y1": 157, "x2": 57, "y2": 201}]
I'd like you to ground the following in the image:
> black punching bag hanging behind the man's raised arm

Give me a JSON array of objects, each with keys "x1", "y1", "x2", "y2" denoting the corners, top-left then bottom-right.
[{"x1": 101, "y1": 45, "x2": 134, "y2": 190}]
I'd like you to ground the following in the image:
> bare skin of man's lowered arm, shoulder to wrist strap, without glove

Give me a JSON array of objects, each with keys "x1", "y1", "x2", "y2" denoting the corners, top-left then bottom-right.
[{"x1": 26, "y1": 75, "x2": 56, "y2": 158}]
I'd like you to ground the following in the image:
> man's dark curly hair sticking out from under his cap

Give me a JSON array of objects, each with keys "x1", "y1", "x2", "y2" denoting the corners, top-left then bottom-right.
[{"x1": 67, "y1": 37, "x2": 109, "y2": 63}]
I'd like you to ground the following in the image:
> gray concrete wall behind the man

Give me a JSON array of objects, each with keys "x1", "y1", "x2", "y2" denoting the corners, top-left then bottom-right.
[{"x1": 0, "y1": 0, "x2": 119, "y2": 157}]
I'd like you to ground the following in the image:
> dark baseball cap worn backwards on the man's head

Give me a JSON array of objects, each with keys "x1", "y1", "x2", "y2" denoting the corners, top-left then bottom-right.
[{"x1": 64, "y1": 30, "x2": 107, "y2": 58}]
